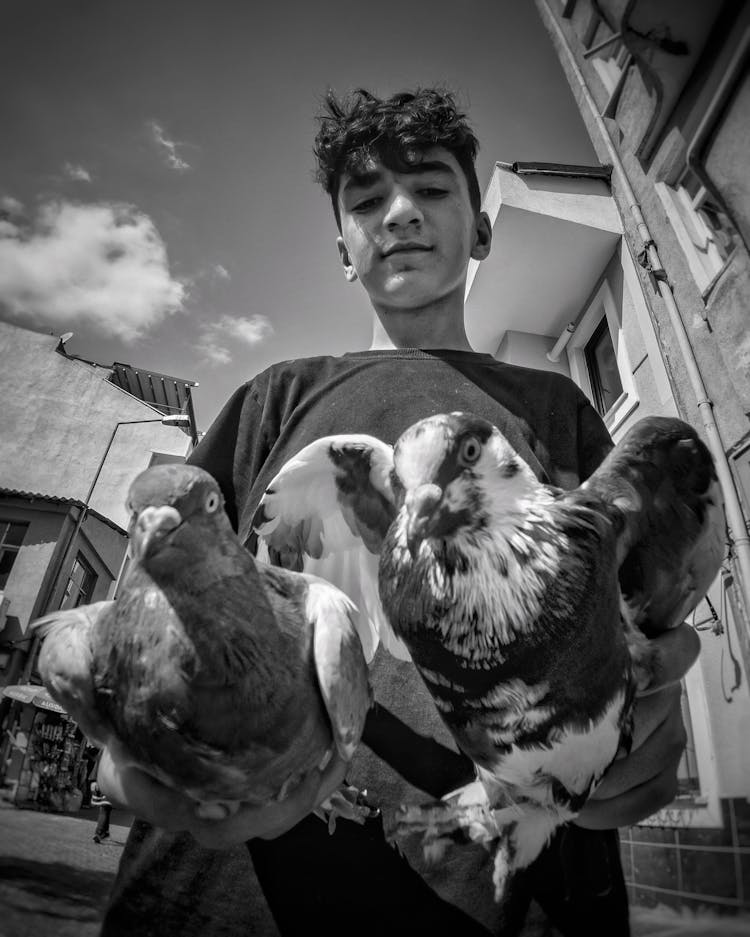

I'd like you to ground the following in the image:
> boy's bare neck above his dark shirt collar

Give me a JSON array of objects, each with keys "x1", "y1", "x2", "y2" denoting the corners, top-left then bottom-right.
[{"x1": 370, "y1": 294, "x2": 474, "y2": 351}]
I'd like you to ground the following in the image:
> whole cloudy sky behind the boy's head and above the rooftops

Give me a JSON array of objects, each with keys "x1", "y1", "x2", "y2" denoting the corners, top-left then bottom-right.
[{"x1": 0, "y1": 0, "x2": 596, "y2": 431}]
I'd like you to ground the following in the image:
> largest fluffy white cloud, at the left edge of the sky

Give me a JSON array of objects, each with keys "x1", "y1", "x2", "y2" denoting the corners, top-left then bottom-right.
[{"x1": 0, "y1": 201, "x2": 185, "y2": 342}]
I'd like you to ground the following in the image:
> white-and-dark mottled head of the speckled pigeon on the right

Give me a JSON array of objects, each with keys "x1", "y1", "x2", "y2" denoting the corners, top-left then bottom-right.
[{"x1": 393, "y1": 413, "x2": 538, "y2": 554}]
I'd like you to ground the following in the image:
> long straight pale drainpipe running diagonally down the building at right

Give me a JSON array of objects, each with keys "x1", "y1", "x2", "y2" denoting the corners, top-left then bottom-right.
[{"x1": 536, "y1": 0, "x2": 750, "y2": 614}]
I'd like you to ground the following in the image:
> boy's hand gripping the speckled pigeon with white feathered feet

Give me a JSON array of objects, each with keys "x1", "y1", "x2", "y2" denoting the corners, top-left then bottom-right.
[{"x1": 573, "y1": 624, "x2": 700, "y2": 830}]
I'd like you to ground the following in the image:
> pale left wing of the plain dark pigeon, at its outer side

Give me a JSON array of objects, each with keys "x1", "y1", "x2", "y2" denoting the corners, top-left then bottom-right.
[{"x1": 32, "y1": 602, "x2": 114, "y2": 745}]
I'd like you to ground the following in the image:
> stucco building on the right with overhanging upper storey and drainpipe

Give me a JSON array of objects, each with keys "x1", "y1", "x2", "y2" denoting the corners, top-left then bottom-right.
[{"x1": 467, "y1": 0, "x2": 750, "y2": 914}]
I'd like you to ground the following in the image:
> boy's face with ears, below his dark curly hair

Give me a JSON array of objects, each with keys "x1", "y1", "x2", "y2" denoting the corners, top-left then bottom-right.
[{"x1": 337, "y1": 147, "x2": 491, "y2": 310}]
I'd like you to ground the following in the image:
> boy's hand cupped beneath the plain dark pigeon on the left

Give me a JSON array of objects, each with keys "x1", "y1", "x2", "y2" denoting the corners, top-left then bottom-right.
[{"x1": 97, "y1": 749, "x2": 348, "y2": 849}]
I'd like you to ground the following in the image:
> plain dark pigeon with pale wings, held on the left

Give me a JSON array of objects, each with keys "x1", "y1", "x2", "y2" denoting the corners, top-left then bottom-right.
[{"x1": 35, "y1": 464, "x2": 372, "y2": 819}]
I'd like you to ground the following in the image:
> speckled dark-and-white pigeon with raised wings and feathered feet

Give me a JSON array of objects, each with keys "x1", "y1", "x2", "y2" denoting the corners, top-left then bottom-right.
[{"x1": 254, "y1": 413, "x2": 726, "y2": 900}]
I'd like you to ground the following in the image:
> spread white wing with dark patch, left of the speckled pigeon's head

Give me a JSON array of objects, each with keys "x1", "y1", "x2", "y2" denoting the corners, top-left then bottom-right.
[{"x1": 253, "y1": 434, "x2": 410, "y2": 663}]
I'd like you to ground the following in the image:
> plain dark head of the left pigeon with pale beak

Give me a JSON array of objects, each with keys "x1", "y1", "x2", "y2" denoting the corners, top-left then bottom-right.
[{"x1": 127, "y1": 464, "x2": 229, "y2": 565}]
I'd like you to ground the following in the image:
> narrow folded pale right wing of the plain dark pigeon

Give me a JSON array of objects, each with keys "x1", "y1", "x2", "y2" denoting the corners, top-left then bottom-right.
[{"x1": 306, "y1": 577, "x2": 372, "y2": 761}]
